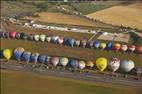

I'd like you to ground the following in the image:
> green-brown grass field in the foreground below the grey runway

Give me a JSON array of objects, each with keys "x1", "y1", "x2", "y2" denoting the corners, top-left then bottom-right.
[{"x1": 1, "y1": 71, "x2": 141, "y2": 94}]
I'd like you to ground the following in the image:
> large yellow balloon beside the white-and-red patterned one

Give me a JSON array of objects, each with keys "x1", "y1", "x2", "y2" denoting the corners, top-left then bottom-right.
[{"x1": 96, "y1": 57, "x2": 107, "y2": 72}]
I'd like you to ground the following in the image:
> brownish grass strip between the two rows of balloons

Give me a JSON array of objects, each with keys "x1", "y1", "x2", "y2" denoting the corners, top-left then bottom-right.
[{"x1": 1, "y1": 39, "x2": 142, "y2": 67}]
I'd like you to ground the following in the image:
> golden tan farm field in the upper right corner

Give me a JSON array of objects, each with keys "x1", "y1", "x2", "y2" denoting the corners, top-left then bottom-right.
[{"x1": 87, "y1": 2, "x2": 142, "y2": 30}]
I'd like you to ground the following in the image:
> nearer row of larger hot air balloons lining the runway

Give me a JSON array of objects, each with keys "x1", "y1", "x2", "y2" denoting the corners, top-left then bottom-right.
[{"x1": 0, "y1": 47, "x2": 135, "y2": 72}]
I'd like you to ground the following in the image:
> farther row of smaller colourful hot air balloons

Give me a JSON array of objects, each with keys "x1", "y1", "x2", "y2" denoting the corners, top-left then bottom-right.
[{"x1": 0, "y1": 32, "x2": 142, "y2": 54}]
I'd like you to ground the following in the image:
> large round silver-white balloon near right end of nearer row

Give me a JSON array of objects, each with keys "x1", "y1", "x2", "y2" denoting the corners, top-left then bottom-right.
[{"x1": 120, "y1": 60, "x2": 135, "y2": 72}]
